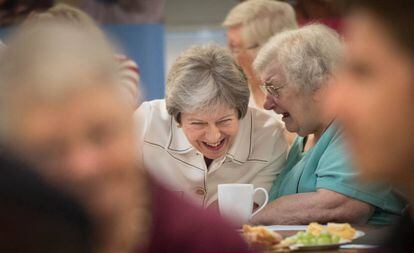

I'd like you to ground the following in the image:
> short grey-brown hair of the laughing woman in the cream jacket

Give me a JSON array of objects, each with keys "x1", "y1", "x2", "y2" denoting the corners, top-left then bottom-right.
[{"x1": 165, "y1": 45, "x2": 250, "y2": 122}]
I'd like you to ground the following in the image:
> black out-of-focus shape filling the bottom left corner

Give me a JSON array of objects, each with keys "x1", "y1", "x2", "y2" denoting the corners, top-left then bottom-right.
[{"x1": 0, "y1": 151, "x2": 92, "y2": 253}]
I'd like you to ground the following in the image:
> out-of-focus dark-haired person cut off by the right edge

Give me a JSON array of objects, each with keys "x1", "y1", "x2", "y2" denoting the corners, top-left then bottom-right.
[{"x1": 329, "y1": 0, "x2": 414, "y2": 252}]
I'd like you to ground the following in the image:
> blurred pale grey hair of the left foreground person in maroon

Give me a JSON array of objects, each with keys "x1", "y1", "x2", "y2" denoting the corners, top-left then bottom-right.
[{"x1": 0, "y1": 21, "x2": 121, "y2": 139}]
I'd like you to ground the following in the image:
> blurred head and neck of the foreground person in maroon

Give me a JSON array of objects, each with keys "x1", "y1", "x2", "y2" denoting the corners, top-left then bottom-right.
[{"x1": 0, "y1": 22, "x2": 149, "y2": 253}]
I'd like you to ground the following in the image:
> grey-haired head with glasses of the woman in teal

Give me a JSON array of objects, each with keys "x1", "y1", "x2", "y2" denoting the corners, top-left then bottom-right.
[{"x1": 254, "y1": 25, "x2": 342, "y2": 136}]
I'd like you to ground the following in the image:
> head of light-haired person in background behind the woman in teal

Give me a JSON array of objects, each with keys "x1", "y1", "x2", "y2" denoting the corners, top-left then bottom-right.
[{"x1": 223, "y1": 0, "x2": 297, "y2": 77}]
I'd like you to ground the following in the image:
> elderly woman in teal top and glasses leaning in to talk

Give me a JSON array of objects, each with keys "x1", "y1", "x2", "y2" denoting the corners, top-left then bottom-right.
[{"x1": 252, "y1": 25, "x2": 402, "y2": 224}]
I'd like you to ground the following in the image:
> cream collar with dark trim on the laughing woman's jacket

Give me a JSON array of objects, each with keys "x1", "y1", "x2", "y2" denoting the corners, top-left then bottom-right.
[{"x1": 167, "y1": 110, "x2": 253, "y2": 163}]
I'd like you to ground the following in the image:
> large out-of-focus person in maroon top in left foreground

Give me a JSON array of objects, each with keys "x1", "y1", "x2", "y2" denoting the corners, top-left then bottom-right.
[{"x1": 0, "y1": 21, "x2": 251, "y2": 253}]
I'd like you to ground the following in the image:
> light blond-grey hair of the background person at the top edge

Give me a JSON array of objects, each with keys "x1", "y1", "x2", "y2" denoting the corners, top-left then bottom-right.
[{"x1": 223, "y1": 0, "x2": 297, "y2": 47}]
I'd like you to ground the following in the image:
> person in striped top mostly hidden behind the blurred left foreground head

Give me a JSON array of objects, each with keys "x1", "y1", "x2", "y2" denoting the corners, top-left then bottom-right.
[{"x1": 25, "y1": 3, "x2": 140, "y2": 109}]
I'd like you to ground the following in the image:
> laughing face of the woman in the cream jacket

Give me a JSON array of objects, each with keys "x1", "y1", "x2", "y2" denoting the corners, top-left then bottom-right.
[{"x1": 181, "y1": 105, "x2": 239, "y2": 159}]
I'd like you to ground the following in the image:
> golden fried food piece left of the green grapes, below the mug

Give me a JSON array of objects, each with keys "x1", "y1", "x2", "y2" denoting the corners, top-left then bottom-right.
[{"x1": 243, "y1": 225, "x2": 283, "y2": 249}]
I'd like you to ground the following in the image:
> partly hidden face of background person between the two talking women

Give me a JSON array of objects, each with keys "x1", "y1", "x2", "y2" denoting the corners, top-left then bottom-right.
[{"x1": 227, "y1": 25, "x2": 259, "y2": 78}]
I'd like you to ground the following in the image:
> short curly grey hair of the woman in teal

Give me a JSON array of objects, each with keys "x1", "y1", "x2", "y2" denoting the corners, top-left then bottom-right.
[{"x1": 253, "y1": 24, "x2": 343, "y2": 91}]
